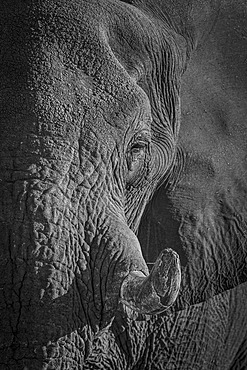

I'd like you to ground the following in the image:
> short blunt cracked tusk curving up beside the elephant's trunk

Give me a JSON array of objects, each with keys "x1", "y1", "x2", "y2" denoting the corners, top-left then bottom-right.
[{"x1": 120, "y1": 248, "x2": 181, "y2": 315}]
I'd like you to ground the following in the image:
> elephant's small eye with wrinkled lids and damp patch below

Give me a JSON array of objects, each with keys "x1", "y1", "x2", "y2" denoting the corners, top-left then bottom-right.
[{"x1": 127, "y1": 140, "x2": 149, "y2": 186}]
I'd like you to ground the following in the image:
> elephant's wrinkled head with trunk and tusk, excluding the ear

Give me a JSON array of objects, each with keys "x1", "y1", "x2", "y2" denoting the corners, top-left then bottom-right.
[{"x1": 0, "y1": 0, "x2": 246, "y2": 369}]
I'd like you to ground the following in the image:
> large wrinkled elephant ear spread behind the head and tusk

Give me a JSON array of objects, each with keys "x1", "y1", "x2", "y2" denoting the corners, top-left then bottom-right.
[{"x1": 139, "y1": 13, "x2": 247, "y2": 309}]
